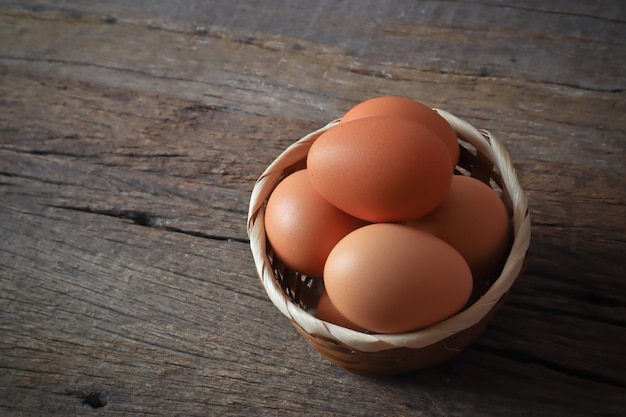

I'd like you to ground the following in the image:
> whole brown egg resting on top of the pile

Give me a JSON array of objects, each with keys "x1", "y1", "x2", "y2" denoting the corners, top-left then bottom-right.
[{"x1": 307, "y1": 117, "x2": 452, "y2": 222}]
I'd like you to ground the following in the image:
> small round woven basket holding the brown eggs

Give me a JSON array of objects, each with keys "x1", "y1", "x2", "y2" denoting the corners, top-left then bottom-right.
[{"x1": 248, "y1": 109, "x2": 530, "y2": 375}]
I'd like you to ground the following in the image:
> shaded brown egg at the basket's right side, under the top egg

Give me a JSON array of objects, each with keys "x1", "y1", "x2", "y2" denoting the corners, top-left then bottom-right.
[{"x1": 407, "y1": 175, "x2": 511, "y2": 285}]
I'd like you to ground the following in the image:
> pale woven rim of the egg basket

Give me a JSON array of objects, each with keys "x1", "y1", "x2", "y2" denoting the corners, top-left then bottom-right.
[{"x1": 247, "y1": 108, "x2": 530, "y2": 352}]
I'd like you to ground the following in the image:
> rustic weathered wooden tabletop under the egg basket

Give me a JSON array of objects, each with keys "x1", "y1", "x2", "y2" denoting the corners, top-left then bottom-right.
[{"x1": 0, "y1": 0, "x2": 626, "y2": 417}]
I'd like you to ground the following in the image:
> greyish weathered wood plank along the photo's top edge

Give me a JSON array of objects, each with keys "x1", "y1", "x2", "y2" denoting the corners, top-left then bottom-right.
[{"x1": 2, "y1": 0, "x2": 626, "y2": 91}]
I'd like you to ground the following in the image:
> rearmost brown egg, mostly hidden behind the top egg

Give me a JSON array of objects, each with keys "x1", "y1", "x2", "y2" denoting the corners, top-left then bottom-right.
[{"x1": 341, "y1": 96, "x2": 460, "y2": 169}]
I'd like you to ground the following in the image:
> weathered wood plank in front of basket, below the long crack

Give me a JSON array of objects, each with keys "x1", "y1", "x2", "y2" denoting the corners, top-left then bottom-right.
[{"x1": 2, "y1": 209, "x2": 624, "y2": 416}]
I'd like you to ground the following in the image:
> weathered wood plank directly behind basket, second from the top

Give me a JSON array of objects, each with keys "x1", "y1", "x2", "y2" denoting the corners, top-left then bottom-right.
[{"x1": 0, "y1": 11, "x2": 626, "y2": 173}]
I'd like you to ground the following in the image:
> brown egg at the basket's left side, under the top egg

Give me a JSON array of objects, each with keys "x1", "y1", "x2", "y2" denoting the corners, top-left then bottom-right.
[{"x1": 264, "y1": 169, "x2": 365, "y2": 277}]
